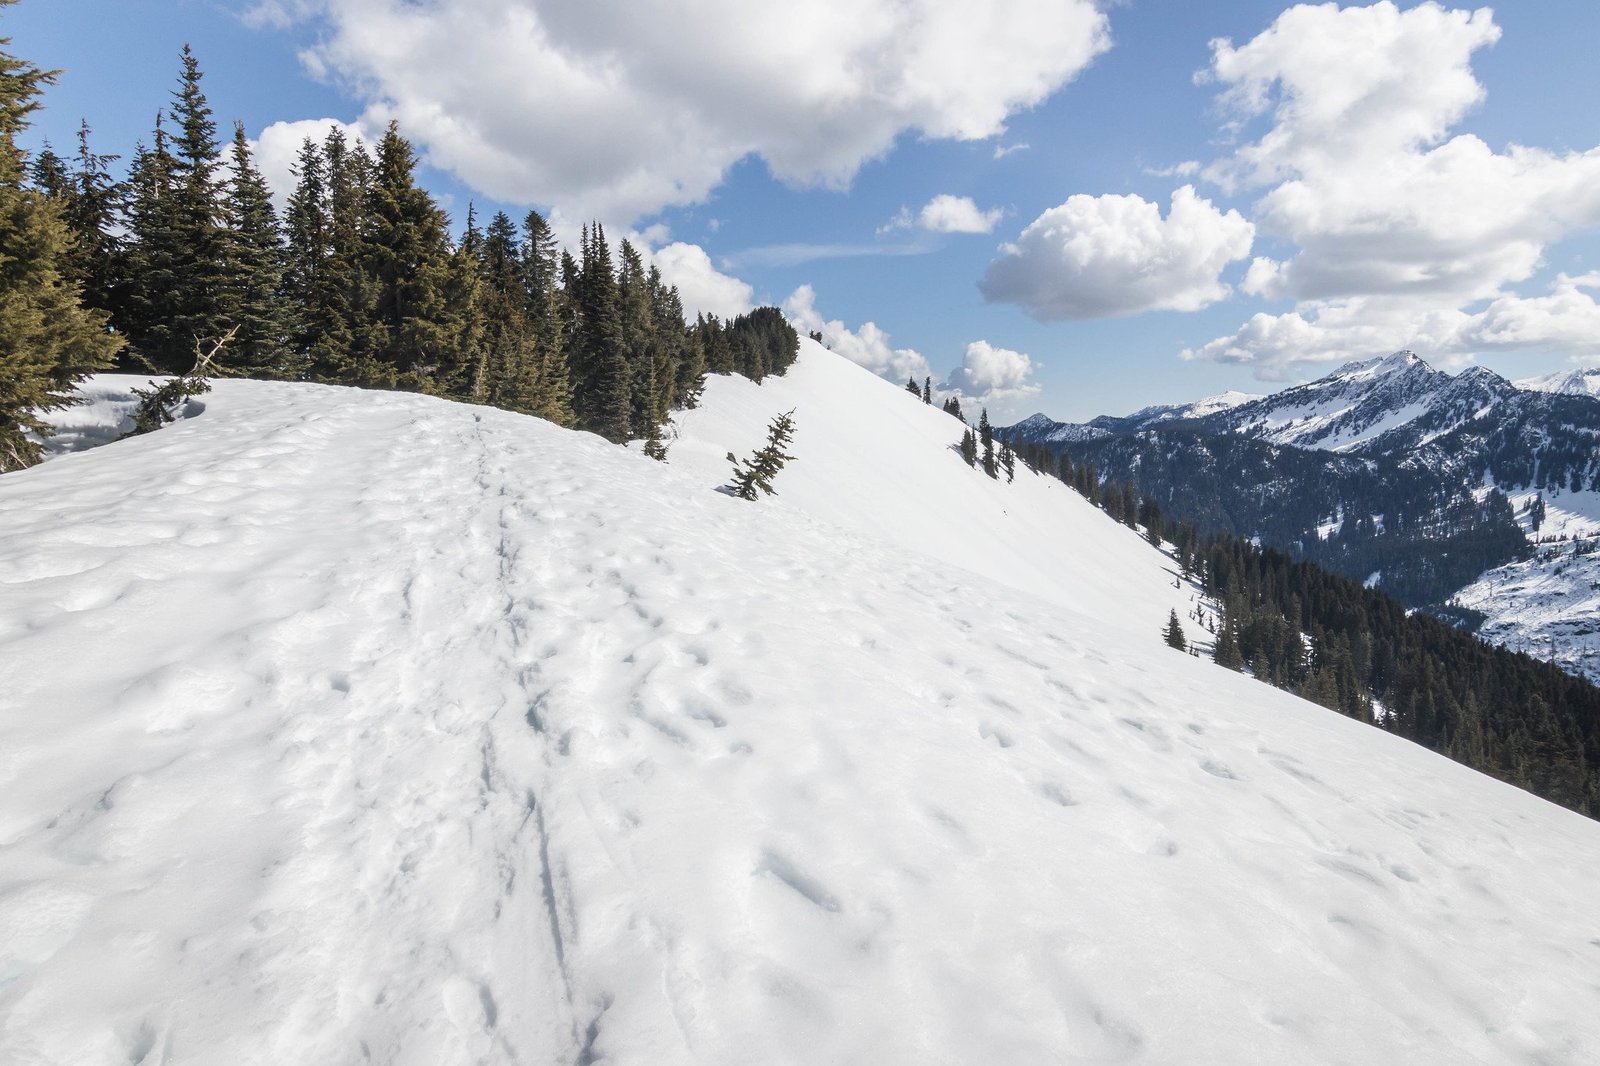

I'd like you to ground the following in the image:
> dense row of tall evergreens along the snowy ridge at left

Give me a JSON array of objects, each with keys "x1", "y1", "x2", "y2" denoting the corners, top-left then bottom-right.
[{"x1": 0, "y1": 39, "x2": 798, "y2": 469}]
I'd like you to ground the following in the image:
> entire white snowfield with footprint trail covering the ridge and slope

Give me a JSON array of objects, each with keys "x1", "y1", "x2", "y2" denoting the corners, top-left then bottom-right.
[{"x1": 0, "y1": 343, "x2": 1600, "y2": 1066}]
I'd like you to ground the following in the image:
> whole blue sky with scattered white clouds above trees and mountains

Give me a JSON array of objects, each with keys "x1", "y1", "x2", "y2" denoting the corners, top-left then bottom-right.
[{"x1": 9, "y1": 0, "x2": 1600, "y2": 421}]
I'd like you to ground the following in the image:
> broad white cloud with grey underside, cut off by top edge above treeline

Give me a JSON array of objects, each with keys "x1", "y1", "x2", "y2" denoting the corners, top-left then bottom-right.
[{"x1": 258, "y1": 0, "x2": 1110, "y2": 221}]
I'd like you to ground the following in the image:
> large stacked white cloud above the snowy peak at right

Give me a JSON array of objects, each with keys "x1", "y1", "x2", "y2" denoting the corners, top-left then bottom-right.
[{"x1": 1187, "y1": 0, "x2": 1600, "y2": 378}]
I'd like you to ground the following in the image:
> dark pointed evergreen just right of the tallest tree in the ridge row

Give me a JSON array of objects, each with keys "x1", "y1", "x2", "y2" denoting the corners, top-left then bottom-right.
[{"x1": 221, "y1": 122, "x2": 294, "y2": 378}]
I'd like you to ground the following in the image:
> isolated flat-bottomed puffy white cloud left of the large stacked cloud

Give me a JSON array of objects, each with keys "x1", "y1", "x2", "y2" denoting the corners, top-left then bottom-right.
[{"x1": 979, "y1": 186, "x2": 1254, "y2": 322}]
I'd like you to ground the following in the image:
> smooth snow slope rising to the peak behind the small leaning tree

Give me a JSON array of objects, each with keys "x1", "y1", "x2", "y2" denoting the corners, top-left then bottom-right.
[{"x1": 669, "y1": 348, "x2": 1194, "y2": 634}]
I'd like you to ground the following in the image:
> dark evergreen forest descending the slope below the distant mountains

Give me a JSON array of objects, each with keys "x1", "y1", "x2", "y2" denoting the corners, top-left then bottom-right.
[{"x1": 1018, "y1": 443, "x2": 1600, "y2": 816}]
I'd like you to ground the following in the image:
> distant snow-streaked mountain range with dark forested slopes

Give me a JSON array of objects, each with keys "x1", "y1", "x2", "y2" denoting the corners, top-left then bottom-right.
[{"x1": 1000, "y1": 352, "x2": 1600, "y2": 679}]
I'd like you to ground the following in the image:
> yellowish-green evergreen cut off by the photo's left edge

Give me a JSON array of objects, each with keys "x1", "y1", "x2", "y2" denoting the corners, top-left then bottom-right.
[{"x1": 0, "y1": 0, "x2": 120, "y2": 472}]
